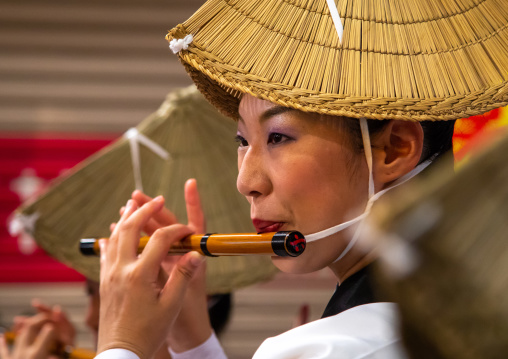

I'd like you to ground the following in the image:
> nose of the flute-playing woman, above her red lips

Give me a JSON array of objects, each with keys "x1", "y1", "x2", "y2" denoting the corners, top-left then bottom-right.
[{"x1": 236, "y1": 148, "x2": 272, "y2": 198}]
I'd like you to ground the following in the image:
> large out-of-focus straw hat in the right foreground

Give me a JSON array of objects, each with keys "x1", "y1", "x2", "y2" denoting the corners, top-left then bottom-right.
[{"x1": 370, "y1": 131, "x2": 508, "y2": 359}]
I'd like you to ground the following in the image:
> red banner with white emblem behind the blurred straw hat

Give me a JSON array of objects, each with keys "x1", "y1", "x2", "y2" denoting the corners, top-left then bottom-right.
[{"x1": 0, "y1": 133, "x2": 118, "y2": 283}]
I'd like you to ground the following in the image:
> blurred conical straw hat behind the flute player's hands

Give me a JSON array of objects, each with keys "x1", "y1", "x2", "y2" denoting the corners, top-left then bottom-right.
[{"x1": 11, "y1": 86, "x2": 277, "y2": 293}]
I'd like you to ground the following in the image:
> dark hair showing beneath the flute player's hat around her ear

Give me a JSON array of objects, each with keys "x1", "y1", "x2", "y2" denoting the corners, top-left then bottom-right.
[{"x1": 342, "y1": 117, "x2": 455, "y2": 163}]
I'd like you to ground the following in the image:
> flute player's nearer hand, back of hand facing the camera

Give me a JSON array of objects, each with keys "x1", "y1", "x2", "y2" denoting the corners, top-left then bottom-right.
[{"x1": 98, "y1": 197, "x2": 203, "y2": 358}]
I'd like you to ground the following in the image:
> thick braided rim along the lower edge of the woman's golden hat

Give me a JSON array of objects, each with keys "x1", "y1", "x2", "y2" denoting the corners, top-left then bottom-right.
[{"x1": 166, "y1": 24, "x2": 508, "y2": 121}]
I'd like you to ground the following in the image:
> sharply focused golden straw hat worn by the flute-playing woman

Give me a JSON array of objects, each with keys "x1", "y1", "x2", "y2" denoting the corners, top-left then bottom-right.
[{"x1": 166, "y1": 0, "x2": 508, "y2": 121}]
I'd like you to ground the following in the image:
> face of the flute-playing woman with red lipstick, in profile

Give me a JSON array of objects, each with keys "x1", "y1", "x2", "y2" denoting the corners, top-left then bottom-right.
[{"x1": 237, "y1": 95, "x2": 368, "y2": 273}]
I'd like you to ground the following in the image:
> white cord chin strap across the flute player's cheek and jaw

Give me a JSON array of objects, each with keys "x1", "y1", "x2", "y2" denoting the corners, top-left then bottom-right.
[{"x1": 305, "y1": 118, "x2": 432, "y2": 263}]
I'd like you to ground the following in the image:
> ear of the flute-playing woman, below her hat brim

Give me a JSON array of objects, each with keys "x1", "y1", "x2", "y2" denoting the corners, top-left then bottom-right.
[{"x1": 372, "y1": 120, "x2": 423, "y2": 191}]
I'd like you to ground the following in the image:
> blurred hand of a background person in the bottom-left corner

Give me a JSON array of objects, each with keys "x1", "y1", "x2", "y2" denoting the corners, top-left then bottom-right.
[{"x1": 0, "y1": 313, "x2": 56, "y2": 359}]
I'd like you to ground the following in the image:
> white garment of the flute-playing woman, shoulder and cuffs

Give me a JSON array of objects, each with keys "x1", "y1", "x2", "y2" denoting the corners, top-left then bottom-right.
[{"x1": 95, "y1": 303, "x2": 407, "y2": 359}]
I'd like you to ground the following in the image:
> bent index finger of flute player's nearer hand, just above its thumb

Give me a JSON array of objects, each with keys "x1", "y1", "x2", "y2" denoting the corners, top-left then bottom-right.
[{"x1": 139, "y1": 224, "x2": 192, "y2": 278}]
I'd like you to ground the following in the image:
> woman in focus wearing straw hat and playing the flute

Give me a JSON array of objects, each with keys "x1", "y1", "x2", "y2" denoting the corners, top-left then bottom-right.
[{"x1": 92, "y1": 0, "x2": 508, "y2": 358}]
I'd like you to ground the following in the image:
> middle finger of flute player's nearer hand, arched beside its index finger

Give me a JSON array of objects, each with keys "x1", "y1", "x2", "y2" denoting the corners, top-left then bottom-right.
[{"x1": 115, "y1": 196, "x2": 164, "y2": 262}]
